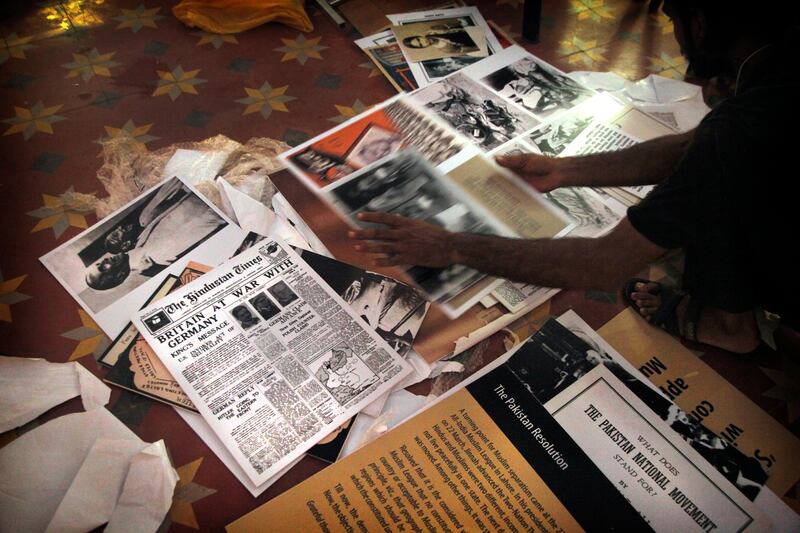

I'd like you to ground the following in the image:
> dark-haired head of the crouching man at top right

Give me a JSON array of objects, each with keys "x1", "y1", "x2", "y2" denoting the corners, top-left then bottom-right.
[{"x1": 664, "y1": 0, "x2": 796, "y2": 78}]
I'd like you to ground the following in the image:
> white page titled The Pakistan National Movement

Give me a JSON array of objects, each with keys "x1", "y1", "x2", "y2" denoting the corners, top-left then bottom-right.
[{"x1": 545, "y1": 365, "x2": 769, "y2": 532}]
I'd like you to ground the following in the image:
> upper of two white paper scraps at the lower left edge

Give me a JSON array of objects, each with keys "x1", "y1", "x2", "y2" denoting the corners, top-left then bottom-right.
[{"x1": 0, "y1": 356, "x2": 111, "y2": 433}]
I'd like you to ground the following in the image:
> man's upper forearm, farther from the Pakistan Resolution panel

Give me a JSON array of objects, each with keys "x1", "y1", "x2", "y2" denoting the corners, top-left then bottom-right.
[{"x1": 558, "y1": 130, "x2": 694, "y2": 187}]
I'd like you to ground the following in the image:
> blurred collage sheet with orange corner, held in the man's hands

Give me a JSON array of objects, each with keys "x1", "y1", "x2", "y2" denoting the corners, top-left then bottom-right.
[{"x1": 282, "y1": 43, "x2": 637, "y2": 318}]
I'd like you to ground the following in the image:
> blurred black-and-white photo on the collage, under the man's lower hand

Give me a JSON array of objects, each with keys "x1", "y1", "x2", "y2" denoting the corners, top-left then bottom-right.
[{"x1": 327, "y1": 150, "x2": 503, "y2": 301}]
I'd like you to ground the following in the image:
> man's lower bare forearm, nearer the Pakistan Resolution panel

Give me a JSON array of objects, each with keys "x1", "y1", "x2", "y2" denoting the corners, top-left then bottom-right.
[{"x1": 451, "y1": 219, "x2": 665, "y2": 290}]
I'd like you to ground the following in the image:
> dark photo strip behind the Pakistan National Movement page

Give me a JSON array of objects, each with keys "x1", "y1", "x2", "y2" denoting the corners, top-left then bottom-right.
[{"x1": 506, "y1": 319, "x2": 767, "y2": 500}]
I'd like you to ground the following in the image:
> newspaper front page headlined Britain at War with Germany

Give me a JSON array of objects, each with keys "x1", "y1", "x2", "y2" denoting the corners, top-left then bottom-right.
[{"x1": 133, "y1": 239, "x2": 411, "y2": 485}]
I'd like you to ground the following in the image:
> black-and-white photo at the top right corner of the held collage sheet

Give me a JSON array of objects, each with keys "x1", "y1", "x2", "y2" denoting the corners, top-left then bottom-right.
[{"x1": 481, "y1": 57, "x2": 593, "y2": 118}]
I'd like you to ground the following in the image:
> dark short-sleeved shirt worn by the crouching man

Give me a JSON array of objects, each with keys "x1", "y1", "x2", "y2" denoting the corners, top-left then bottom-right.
[{"x1": 628, "y1": 40, "x2": 800, "y2": 328}]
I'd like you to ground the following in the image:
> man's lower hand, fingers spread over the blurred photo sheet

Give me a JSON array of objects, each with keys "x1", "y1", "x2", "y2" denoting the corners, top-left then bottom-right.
[{"x1": 348, "y1": 213, "x2": 457, "y2": 268}]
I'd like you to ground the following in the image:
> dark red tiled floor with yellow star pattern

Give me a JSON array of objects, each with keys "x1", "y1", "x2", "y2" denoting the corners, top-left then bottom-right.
[{"x1": 0, "y1": 0, "x2": 800, "y2": 531}]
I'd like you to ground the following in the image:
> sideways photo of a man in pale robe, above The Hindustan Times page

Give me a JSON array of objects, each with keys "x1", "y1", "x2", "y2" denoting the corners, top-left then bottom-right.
[{"x1": 41, "y1": 178, "x2": 242, "y2": 336}]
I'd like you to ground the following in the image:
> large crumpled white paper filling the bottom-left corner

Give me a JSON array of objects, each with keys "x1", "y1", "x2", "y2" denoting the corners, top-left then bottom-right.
[{"x1": 0, "y1": 408, "x2": 141, "y2": 533}]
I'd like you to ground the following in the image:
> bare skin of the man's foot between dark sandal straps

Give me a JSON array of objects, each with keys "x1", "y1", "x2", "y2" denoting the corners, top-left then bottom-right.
[{"x1": 631, "y1": 282, "x2": 760, "y2": 353}]
